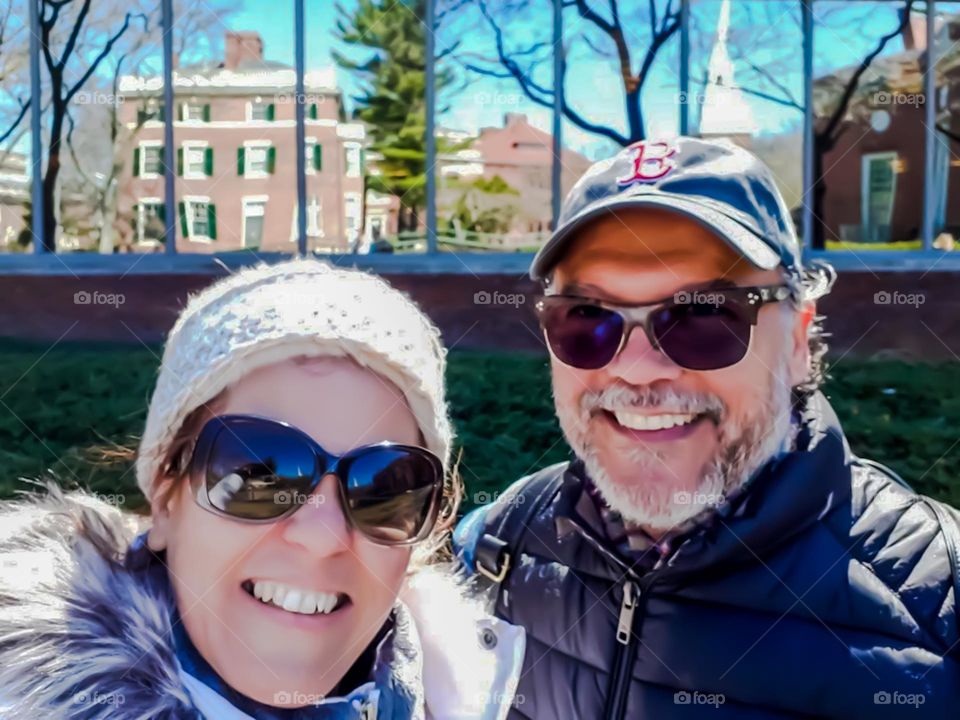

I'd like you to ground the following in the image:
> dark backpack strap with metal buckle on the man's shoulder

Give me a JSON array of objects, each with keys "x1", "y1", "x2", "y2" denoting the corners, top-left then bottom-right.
[{"x1": 475, "y1": 467, "x2": 565, "y2": 583}]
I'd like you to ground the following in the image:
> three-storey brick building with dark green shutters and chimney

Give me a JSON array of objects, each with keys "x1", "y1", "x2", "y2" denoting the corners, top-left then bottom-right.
[{"x1": 118, "y1": 32, "x2": 365, "y2": 253}]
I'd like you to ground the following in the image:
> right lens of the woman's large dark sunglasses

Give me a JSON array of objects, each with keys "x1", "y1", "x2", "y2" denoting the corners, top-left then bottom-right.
[{"x1": 344, "y1": 447, "x2": 443, "y2": 545}]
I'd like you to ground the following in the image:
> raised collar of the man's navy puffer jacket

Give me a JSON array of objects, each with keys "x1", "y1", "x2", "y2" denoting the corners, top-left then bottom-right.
[{"x1": 556, "y1": 392, "x2": 853, "y2": 577}]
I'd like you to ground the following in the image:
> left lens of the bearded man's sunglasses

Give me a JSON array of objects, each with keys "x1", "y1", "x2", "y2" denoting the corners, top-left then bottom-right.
[{"x1": 541, "y1": 299, "x2": 623, "y2": 370}]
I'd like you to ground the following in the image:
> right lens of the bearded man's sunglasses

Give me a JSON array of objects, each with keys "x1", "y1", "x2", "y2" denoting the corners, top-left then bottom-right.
[{"x1": 651, "y1": 303, "x2": 752, "y2": 370}]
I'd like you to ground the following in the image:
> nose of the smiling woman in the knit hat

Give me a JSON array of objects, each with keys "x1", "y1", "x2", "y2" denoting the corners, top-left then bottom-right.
[{"x1": 283, "y1": 474, "x2": 351, "y2": 556}]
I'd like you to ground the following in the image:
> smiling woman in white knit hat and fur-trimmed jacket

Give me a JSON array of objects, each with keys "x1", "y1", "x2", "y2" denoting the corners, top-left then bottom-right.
[{"x1": 0, "y1": 260, "x2": 524, "y2": 720}]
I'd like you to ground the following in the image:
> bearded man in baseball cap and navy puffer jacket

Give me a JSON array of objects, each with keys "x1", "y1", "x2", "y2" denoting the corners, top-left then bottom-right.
[{"x1": 455, "y1": 138, "x2": 960, "y2": 720}]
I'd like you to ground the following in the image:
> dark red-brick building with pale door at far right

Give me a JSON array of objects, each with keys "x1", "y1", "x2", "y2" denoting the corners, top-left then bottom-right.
[{"x1": 814, "y1": 14, "x2": 960, "y2": 249}]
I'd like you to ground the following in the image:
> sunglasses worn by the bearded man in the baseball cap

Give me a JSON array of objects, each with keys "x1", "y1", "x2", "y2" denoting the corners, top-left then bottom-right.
[{"x1": 536, "y1": 285, "x2": 794, "y2": 370}]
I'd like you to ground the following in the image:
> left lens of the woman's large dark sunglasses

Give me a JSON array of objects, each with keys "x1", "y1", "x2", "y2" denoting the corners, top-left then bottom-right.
[{"x1": 205, "y1": 421, "x2": 322, "y2": 520}]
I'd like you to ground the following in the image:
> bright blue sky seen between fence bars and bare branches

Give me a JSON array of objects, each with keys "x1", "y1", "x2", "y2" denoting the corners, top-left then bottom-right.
[{"x1": 221, "y1": 0, "x2": 920, "y2": 156}]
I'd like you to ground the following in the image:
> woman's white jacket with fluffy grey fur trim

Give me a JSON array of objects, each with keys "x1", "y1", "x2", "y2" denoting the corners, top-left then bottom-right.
[{"x1": 0, "y1": 485, "x2": 525, "y2": 720}]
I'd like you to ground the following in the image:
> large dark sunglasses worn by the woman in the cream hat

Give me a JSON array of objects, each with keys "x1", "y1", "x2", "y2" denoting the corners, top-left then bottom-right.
[{"x1": 189, "y1": 415, "x2": 444, "y2": 545}]
